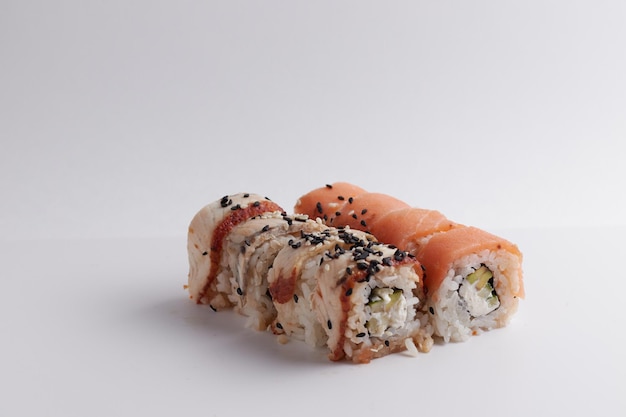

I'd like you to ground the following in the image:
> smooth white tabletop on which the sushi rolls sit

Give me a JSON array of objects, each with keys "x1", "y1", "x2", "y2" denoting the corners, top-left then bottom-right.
[{"x1": 0, "y1": 229, "x2": 626, "y2": 416}]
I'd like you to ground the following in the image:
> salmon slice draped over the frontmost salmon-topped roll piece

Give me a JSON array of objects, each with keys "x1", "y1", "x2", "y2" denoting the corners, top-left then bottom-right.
[{"x1": 416, "y1": 226, "x2": 524, "y2": 298}]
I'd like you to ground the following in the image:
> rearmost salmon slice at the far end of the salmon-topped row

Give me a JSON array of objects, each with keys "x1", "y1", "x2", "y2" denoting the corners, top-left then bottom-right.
[{"x1": 293, "y1": 182, "x2": 366, "y2": 222}]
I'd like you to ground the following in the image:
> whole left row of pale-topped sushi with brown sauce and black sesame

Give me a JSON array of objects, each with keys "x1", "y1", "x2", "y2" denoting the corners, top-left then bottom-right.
[{"x1": 187, "y1": 193, "x2": 433, "y2": 363}]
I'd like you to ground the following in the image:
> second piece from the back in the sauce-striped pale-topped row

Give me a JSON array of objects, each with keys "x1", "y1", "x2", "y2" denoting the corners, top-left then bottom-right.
[{"x1": 225, "y1": 212, "x2": 327, "y2": 330}]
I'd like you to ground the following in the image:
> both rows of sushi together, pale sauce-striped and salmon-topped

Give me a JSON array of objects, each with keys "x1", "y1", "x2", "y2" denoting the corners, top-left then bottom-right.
[{"x1": 185, "y1": 182, "x2": 524, "y2": 363}]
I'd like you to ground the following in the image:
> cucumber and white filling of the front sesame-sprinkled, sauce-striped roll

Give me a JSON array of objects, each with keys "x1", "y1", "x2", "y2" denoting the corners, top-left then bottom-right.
[{"x1": 365, "y1": 288, "x2": 408, "y2": 337}]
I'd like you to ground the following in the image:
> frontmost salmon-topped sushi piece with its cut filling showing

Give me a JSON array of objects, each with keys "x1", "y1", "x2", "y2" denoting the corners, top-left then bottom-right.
[{"x1": 417, "y1": 227, "x2": 524, "y2": 342}]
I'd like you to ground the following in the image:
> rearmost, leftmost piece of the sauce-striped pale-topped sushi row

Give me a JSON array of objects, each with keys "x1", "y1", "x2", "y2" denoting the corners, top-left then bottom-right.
[{"x1": 187, "y1": 193, "x2": 284, "y2": 310}]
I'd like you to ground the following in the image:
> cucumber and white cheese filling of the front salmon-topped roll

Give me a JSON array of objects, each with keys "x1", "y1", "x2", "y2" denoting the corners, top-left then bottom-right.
[{"x1": 459, "y1": 265, "x2": 500, "y2": 317}]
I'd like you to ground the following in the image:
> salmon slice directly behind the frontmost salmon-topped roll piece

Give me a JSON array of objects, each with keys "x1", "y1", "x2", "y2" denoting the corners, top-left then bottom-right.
[{"x1": 369, "y1": 207, "x2": 460, "y2": 254}]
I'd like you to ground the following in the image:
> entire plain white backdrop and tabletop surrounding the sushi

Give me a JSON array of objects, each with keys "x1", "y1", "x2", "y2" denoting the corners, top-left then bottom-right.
[{"x1": 0, "y1": 0, "x2": 626, "y2": 416}]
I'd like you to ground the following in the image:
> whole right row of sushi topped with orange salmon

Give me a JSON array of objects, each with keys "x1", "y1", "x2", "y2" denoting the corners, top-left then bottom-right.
[{"x1": 294, "y1": 183, "x2": 524, "y2": 342}]
